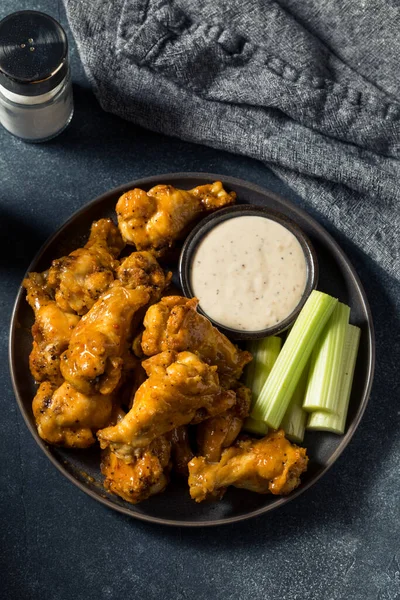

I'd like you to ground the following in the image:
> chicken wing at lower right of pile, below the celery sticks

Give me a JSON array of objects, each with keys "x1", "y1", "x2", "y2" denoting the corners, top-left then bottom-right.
[{"x1": 188, "y1": 430, "x2": 308, "y2": 502}]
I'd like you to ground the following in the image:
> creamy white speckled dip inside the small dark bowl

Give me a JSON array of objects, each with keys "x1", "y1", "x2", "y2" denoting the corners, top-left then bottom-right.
[{"x1": 191, "y1": 215, "x2": 307, "y2": 331}]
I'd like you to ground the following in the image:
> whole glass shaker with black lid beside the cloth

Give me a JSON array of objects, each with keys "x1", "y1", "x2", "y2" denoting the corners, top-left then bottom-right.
[{"x1": 0, "y1": 10, "x2": 74, "y2": 142}]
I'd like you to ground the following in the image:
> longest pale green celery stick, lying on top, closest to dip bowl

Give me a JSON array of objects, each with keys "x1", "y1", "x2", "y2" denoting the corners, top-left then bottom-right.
[{"x1": 251, "y1": 290, "x2": 337, "y2": 429}]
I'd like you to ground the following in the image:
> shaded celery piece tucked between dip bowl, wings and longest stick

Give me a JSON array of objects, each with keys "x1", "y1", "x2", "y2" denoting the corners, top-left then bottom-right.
[{"x1": 244, "y1": 336, "x2": 282, "y2": 402}]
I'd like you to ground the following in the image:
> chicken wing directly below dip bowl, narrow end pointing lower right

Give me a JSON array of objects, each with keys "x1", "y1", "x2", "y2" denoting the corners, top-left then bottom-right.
[{"x1": 142, "y1": 296, "x2": 252, "y2": 388}]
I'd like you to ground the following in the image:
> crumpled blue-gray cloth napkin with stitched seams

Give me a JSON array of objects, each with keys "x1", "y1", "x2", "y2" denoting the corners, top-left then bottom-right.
[{"x1": 64, "y1": 0, "x2": 400, "y2": 279}]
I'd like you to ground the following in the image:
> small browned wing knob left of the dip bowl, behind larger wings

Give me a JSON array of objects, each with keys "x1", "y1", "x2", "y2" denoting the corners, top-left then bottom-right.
[{"x1": 117, "y1": 252, "x2": 172, "y2": 303}]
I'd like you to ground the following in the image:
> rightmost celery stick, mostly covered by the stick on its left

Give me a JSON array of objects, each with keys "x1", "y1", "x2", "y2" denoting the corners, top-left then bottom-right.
[{"x1": 307, "y1": 325, "x2": 360, "y2": 435}]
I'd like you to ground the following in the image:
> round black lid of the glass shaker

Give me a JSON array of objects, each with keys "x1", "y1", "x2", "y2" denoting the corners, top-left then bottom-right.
[{"x1": 0, "y1": 10, "x2": 68, "y2": 96}]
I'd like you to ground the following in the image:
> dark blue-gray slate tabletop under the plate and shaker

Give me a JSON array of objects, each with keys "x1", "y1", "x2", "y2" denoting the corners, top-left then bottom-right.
[{"x1": 0, "y1": 0, "x2": 400, "y2": 600}]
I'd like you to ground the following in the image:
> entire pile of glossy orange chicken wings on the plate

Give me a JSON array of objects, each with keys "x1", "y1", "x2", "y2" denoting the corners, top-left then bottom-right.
[{"x1": 23, "y1": 182, "x2": 308, "y2": 503}]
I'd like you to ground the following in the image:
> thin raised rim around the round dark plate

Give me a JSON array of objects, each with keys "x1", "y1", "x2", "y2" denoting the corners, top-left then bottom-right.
[{"x1": 8, "y1": 171, "x2": 376, "y2": 527}]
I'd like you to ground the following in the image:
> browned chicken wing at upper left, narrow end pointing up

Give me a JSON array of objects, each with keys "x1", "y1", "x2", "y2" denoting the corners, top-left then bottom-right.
[{"x1": 48, "y1": 219, "x2": 124, "y2": 315}]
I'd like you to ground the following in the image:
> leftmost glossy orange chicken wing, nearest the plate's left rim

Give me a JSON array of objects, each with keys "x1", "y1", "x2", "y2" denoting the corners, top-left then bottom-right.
[{"x1": 23, "y1": 273, "x2": 79, "y2": 385}]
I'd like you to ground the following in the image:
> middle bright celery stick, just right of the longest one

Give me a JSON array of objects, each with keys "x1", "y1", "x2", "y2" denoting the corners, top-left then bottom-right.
[{"x1": 303, "y1": 302, "x2": 350, "y2": 413}]
